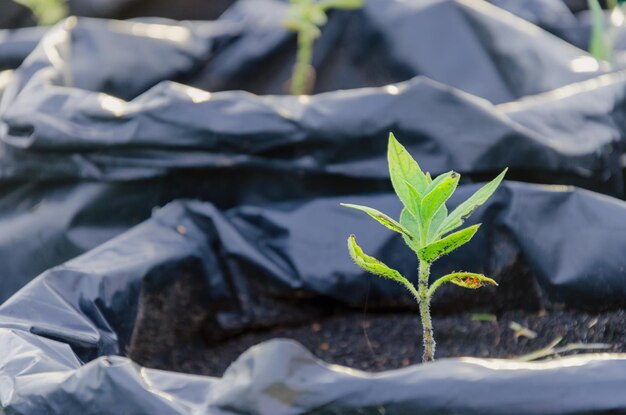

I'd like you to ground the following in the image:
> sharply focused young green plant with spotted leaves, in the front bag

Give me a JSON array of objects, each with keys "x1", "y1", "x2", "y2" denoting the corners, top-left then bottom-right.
[{"x1": 342, "y1": 134, "x2": 507, "y2": 362}]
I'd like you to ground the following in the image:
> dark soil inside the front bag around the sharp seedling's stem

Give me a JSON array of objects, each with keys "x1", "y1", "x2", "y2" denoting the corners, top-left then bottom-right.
[{"x1": 127, "y1": 272, "x2": 626, "y2": 376}]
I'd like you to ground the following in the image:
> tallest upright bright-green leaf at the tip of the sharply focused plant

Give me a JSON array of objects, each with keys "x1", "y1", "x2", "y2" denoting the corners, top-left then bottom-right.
[{"x1": 387, "y1": 133, "x2": 428, "y2": 211}]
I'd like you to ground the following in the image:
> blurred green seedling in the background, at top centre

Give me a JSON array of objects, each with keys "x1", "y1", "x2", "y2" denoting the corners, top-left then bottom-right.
[{"x1": 284, "y1": 0, "x2": 363, "y2": 95}]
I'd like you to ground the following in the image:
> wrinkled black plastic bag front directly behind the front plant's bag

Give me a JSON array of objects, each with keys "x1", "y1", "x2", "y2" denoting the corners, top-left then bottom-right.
[{"x1": 0, "y1": 73, "x2": 624, "y2": 299}]
